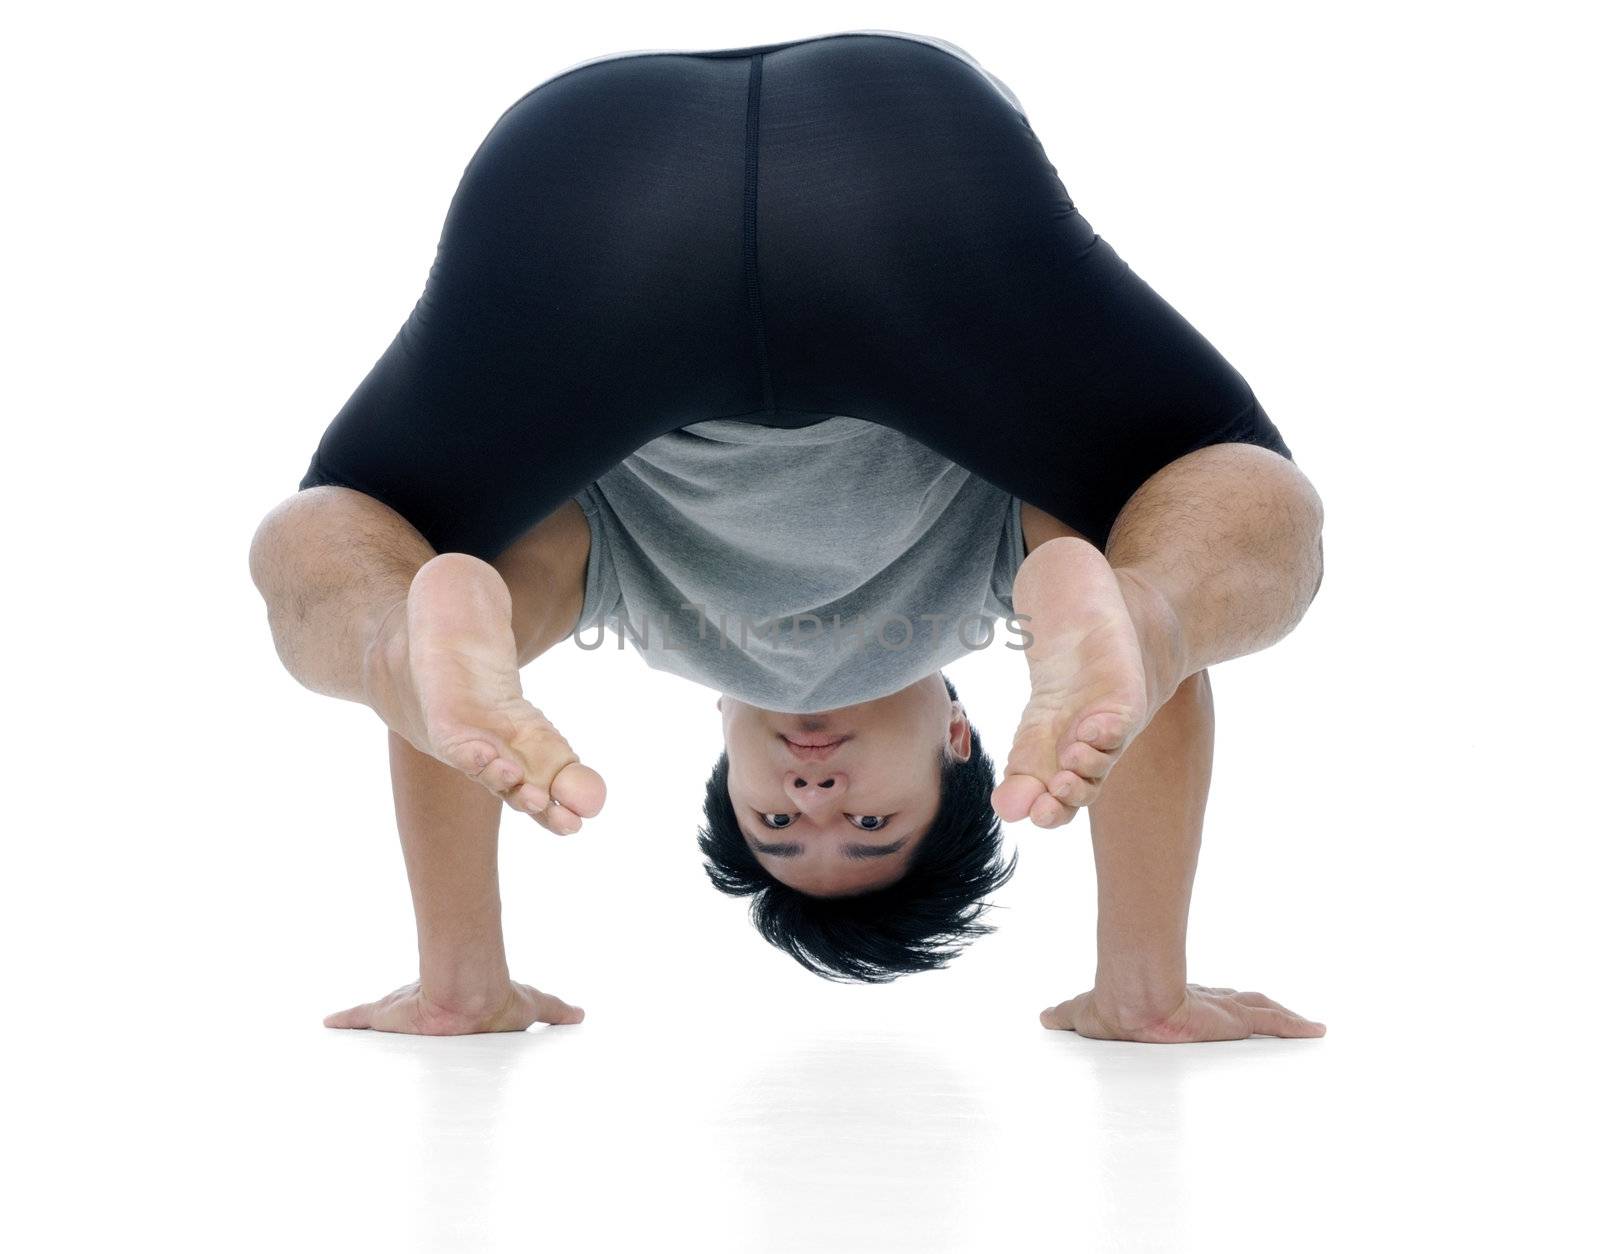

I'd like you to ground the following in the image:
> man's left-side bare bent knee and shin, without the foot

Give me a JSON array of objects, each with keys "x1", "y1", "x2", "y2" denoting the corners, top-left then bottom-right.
[{"x1": 250, "y1": 485, "x2": 435, "y2": 704}]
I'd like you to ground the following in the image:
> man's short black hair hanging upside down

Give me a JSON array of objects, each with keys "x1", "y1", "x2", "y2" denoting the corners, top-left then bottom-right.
[{"x1": 699, "y1": 675, "x2": 1016, "y2": 984}]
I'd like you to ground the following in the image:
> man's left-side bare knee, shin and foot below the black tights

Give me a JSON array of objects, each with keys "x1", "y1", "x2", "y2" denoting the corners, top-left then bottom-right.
[{"x1": 250, "y1": 485, "x2": 605, "y2": 833}]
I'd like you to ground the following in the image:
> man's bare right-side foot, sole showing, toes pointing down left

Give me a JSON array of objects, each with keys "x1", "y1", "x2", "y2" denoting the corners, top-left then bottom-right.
[{"x1": 990, "y1": 536, "x2": 1182, "y2": 827}]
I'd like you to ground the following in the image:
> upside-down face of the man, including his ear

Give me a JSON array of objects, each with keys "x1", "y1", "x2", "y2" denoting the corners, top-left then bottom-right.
[{"x1": 717, "y1": 673, "x2": 971, "y2": 897}]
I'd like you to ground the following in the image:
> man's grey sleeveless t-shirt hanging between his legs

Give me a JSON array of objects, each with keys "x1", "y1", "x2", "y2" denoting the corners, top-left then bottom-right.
[{"x1": 576, "y1": 416, "x2": 1024, "y2": 713}]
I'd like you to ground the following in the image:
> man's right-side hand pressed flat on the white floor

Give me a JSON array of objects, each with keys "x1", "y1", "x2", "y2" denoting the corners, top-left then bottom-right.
[{"x1": 1038, "y1": 984, "x2": 1328, "y2": 1044}]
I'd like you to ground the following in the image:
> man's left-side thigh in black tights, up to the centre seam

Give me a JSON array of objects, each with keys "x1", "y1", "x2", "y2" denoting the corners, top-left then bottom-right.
[{"x1": 299, "y1": 56, "x2": 760, "y2": 560}]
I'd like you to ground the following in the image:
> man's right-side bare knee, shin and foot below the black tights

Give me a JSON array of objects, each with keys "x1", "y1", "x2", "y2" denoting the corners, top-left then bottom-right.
[{"x1": 994, "y1": 443, "x2": 1323, "y2": 827}]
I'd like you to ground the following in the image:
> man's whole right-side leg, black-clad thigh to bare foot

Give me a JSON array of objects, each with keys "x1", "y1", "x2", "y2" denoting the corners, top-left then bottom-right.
[{"x1": 748, "y1": 42, "x2": 1322, "y2": 825}]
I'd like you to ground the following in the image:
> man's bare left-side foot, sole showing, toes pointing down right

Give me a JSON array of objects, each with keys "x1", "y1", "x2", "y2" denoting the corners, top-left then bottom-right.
[{"x1": 366, "y1": 553, "x2": 605, "y2": 835}]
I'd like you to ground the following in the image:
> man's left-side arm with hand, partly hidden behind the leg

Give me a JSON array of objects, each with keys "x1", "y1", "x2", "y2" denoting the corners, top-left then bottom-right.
[{"x1": 326, "y1": 502, "x2": 589, "y2": 1035}]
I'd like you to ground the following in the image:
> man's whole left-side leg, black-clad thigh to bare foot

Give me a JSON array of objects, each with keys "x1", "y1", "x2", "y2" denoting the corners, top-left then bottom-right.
[{"x1": 251, "y1": 58, "x2": 758, "y2": 812}]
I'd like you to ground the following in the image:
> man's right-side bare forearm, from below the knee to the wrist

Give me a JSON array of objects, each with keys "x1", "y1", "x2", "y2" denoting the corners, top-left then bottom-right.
[{"x1": 1090, "y1": 670, "x2": 1214, "y2": 1012}]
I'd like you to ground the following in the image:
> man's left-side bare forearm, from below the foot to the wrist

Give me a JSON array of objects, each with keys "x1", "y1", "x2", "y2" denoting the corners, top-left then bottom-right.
[{"x1": 389, "y1": 731, "x2": 510, "y2": 1009}]
